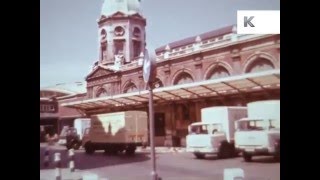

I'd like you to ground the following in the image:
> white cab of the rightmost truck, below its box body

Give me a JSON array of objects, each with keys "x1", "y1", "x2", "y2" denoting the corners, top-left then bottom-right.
[{"x1": 235, "y1": 118, "x2": 280, "y2": 162}]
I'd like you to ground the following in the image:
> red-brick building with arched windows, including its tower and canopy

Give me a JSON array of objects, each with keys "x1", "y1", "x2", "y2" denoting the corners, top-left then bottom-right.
[{"x1": 64, "y1": 0, "x2": 280, "y2": 145}]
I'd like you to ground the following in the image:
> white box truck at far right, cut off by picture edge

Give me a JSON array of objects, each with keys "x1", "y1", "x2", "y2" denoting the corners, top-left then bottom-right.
[{"x1": 235, "y1": 100, "x2": 280, "y2": 162}]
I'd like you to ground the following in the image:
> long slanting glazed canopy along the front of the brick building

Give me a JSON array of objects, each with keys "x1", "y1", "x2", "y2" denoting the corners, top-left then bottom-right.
[{"x1": 62, "y1": 69, "x2": 280, "y2": 110}]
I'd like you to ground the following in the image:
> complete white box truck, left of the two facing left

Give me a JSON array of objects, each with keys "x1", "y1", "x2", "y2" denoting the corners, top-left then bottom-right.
[{"x1": 186, "y1": 106, "x2": 247, "y2": 159}]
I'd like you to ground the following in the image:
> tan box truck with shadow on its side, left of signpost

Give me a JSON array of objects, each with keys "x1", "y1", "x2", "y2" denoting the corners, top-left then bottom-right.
[{"x1": 83, "y1": 111, "x2": 148, "y2": 155}]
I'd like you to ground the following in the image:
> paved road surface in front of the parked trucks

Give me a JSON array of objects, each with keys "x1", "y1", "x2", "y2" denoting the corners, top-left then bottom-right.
[{"x1": 40, "y1": 143, "x2": 280, "y2": 180}]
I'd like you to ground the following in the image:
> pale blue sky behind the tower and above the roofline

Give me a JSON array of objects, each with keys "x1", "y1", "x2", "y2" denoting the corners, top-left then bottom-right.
[{"x1": 40, "y1": 0, "x2": 280, "y2": 87}]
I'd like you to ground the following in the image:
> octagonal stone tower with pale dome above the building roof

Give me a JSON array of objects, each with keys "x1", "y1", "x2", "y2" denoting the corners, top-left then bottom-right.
[{"x1": 98, "y1": 0, "x2": 146, "y2": 69}]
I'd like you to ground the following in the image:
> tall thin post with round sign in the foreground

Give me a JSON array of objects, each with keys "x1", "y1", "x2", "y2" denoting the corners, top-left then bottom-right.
[{"x1": 143, "y1": 49, "x2": 158, "y2": 180}]
